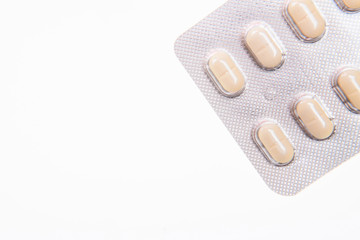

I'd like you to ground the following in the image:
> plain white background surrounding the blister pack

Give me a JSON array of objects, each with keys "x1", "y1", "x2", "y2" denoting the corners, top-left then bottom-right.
[{"x1": 0, "y1": 0, "x2": 360, "y2": 240}]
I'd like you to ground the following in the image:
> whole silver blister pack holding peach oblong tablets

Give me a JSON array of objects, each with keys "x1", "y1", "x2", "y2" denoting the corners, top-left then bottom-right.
[{"x1": 175, "y1": 0, "x2": 360, "y2": 195}]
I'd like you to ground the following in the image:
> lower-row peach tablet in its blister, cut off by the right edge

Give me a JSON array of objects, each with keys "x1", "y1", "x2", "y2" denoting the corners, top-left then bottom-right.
[{"x1": 332, "y1": 67, "x2": 360, "y2": 113}]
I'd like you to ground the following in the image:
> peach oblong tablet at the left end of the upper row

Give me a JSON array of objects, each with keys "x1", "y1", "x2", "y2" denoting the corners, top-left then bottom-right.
[{"x1": 206, "y1": 50, "x2": 245, "y2": 97}]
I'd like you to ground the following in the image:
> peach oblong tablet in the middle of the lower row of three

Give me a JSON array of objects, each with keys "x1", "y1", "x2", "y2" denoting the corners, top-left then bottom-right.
[{"x1": 293, "y1": 95, "x2": 335, "y2": 140}]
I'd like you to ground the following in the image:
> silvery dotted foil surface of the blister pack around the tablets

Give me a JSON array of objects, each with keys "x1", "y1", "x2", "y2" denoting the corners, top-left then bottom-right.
[{"x1": 175, "y1": 0, "x2": 360, "y2": 195}]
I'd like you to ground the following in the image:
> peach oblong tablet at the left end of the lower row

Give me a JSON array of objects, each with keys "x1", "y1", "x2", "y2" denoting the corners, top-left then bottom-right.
[{"x1": 253, "y1": 121, "x2": 295, "y2": 166}]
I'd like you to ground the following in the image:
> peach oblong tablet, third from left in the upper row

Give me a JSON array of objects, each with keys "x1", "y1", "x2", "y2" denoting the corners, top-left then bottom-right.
[{"x1": 284, "y1": 0, "x2": 326, "y2": 42}]
